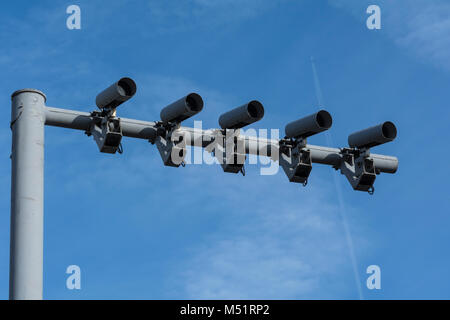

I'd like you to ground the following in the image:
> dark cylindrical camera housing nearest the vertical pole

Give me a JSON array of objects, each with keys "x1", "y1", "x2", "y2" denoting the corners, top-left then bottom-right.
[{"x1": 95, "y1": 78, "x2": 136, "y2": 109}]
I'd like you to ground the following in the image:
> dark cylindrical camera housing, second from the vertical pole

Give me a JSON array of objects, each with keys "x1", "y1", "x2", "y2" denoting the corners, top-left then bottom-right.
[{"x1": 160, "y1": 93, "x2": 203, "y2": 123}]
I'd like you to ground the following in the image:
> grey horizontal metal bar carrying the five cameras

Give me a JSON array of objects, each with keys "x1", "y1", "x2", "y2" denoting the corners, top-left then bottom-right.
[{"x1": 45, "y1": 107, "x2": 398, "y2": 173}]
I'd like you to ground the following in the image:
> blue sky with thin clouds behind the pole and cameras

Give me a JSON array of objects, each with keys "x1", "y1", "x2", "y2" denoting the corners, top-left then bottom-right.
[{"x1": 0, "y1": 0, "x2": 450, "y2": 299}]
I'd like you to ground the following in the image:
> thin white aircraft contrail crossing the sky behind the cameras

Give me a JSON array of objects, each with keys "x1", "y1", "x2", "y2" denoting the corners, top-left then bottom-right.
[{"x1": 311, "y1": 57, "x2": 364, "y2": 300}]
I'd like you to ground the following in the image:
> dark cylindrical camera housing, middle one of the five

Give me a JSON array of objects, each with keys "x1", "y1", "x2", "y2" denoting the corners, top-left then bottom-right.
[{"x1": 219, "y1": 100, "x2": 264, "y2": 129}]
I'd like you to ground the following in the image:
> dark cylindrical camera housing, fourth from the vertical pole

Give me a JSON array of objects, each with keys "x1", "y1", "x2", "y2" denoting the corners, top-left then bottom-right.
[{"x1": 285, "y1": 110, "x2": 333, "y2": 138}]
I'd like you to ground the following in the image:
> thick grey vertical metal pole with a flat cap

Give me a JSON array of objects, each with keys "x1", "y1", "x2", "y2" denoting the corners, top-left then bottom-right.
[{"x1": 9, "y1": 89, "x2": 46, "y2": 300}]
